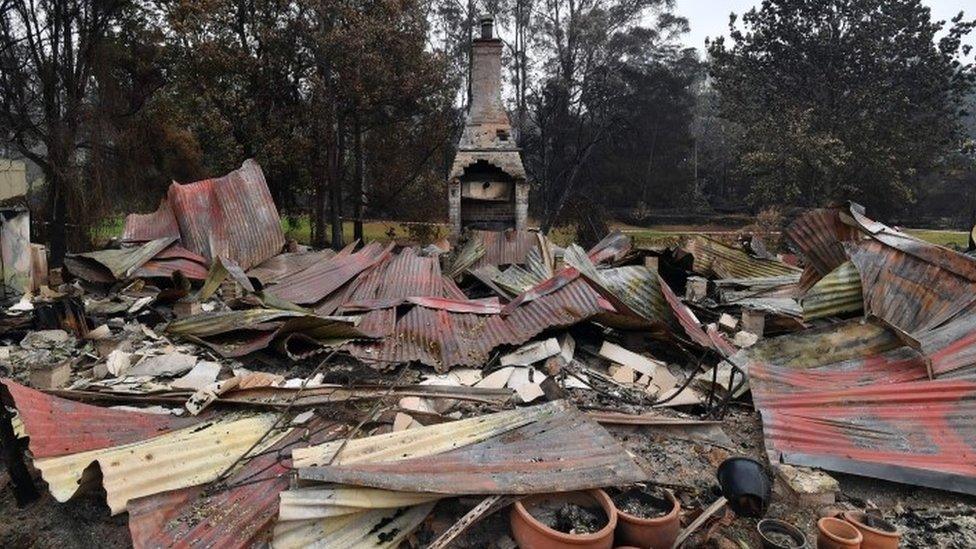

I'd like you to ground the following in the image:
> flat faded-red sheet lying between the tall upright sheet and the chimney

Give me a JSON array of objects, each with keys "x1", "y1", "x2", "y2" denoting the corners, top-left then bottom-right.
[{"x1": 267, "y1": 242, "x2": 392, "y2": 305}]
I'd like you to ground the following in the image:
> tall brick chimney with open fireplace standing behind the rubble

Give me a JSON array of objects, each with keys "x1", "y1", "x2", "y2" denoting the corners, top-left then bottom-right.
[{"x1": 448, "y1": 17, "x2": 528, "y2": 232}]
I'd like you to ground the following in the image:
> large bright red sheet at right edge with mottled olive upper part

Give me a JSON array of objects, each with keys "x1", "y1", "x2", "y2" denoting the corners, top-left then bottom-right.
[{"x1": 732, "y1": 321, "x2": 976, "y2": 494}]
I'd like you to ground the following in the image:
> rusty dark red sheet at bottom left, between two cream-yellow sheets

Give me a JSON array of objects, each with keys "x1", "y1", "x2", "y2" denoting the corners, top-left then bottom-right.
[{"x1": 128, "y1": 420, "x2": 341, "y2": 548}]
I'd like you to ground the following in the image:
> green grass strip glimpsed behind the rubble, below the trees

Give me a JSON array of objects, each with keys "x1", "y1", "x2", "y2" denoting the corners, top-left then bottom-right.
[{"x1": 92, "y1": 216, "x2": 969, "y2": 248}]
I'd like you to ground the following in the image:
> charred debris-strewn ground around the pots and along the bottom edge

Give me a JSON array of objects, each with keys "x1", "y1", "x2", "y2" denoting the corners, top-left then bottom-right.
[{"x1": 0, "y1": 398, "x2": 976, "y2": 549}]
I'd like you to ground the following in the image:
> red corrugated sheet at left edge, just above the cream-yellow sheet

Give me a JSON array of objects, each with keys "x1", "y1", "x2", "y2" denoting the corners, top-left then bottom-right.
[{"x1": 0, "y1": 379, "x2": 200, "y2": 458}]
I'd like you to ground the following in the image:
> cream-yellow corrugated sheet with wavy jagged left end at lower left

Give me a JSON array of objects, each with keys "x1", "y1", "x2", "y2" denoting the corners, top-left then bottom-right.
[{"x1": 34, "y1": 414, "x2": 280, "y2": 515}]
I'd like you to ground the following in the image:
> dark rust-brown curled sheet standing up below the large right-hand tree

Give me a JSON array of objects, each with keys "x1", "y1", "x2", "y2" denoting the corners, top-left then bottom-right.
[{"x1": 786, "y1": 208, "x2": 863, "y2": 293}]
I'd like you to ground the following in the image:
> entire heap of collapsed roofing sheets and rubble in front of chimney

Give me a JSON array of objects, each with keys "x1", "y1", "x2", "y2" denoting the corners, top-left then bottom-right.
[{"x1": 0, "y1": 174, "x2": 976, "y2": 547}]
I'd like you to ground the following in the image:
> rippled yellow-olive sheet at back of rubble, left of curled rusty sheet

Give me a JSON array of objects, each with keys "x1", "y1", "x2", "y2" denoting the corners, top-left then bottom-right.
[{"x1": 684, "y1": 236, "x2": 800, "y2": 278}]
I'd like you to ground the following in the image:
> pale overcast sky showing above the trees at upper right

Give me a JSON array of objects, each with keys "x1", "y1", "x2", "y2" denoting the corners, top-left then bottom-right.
[{"x1": 675, "y1": 0, "x2": 976, "y2": 50}]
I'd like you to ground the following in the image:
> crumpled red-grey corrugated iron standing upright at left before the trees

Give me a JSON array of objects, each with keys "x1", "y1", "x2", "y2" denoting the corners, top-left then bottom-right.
[{"x1": 123, "y1": 159, "x2": 285, "y2": 270}]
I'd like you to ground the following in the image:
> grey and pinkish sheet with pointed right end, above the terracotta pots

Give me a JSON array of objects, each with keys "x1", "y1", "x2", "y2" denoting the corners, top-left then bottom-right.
[{"x1": 299, "y1": 401, "x2": 647, "y2": 495}]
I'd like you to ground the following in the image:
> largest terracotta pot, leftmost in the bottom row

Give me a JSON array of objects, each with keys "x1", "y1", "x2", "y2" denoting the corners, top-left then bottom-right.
[{"x1": 511, "y1": 490, "x2": 617, "y2": 549}]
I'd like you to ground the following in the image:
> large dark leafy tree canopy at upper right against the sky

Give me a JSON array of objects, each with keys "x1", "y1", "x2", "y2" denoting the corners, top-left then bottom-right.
[{"x1": 709, "y1": 0, "x2": 976, "y2": 212}]
